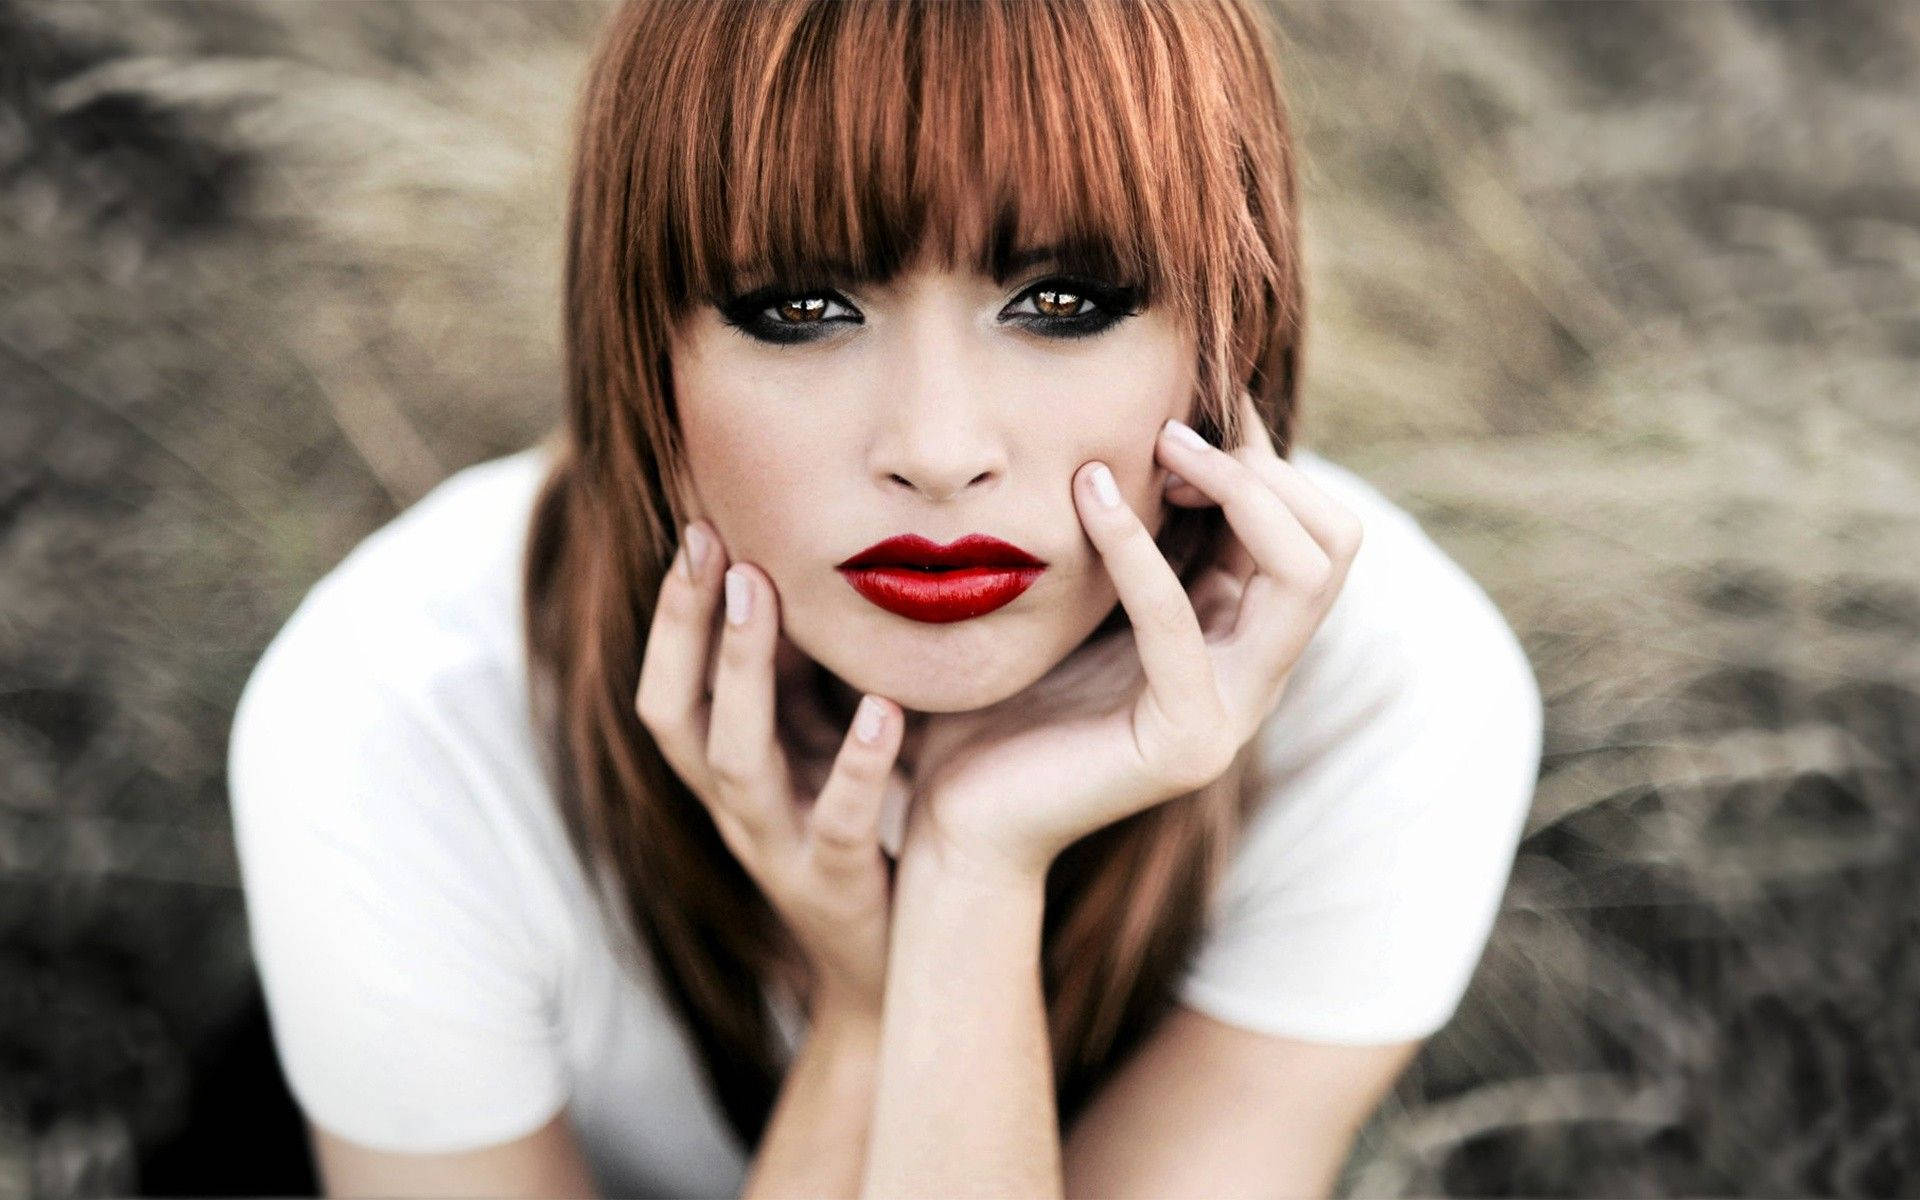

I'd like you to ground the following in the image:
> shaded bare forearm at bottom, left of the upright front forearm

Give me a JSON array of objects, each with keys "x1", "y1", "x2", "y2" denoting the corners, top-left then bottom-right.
[{"x1": 741, "y1": 1004, "x2": 879, "y2": 1200}]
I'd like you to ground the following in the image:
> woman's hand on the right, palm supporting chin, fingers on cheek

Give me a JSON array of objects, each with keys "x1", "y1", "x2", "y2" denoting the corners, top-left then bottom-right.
[{"x1": 902, "y1": 396, "x2": 1361, "y2": 877}]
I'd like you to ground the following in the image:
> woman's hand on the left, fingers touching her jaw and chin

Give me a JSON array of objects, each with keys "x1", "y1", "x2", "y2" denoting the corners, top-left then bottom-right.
[{"x1": 634, "y1": 520, "x2": 904, "y2": 1021}]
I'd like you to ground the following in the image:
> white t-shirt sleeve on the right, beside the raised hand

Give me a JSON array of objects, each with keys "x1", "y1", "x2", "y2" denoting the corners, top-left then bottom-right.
[{"x1": 1179, "y1": 510, "x2": 1544, "y2": 1044}]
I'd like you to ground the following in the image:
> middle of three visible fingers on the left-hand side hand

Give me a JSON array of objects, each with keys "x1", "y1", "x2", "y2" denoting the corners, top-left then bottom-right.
[{"x1": 707, "y1": 563, "x2": 799, "y2": 839}]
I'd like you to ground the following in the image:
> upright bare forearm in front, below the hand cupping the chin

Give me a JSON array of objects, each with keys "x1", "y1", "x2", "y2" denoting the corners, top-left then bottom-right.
[{"x1": 860, "y1": 851, "x2": 1062, "y2": 1196}]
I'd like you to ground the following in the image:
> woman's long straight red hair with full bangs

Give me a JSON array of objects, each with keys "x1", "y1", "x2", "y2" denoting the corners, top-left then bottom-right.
[{"x1": 526, "y1": 0, "x2": 1304, "y2": 1148}]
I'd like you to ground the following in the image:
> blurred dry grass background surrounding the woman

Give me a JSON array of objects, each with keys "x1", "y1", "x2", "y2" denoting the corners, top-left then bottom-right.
[{"x1": 0, "y1": 0, "x2": 1920, "y2": 1198}]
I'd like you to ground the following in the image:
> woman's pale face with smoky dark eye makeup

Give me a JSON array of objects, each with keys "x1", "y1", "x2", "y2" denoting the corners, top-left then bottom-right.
[{"x1": 672, "y1": 245, "x2": 1194, "y2": 712}]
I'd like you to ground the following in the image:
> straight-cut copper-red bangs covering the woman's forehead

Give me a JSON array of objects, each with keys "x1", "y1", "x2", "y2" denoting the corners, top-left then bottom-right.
[{"x1": 628, "y1": 0, "x2": 1296, "y2": 430}]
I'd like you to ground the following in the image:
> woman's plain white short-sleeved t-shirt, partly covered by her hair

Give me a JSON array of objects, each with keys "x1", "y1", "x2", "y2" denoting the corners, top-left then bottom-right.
[{"x1": 228, "y1": 447, "x2": 1542, "y2": 1196}]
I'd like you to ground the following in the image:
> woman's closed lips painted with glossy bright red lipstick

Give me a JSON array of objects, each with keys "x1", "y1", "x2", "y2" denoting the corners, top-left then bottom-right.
[{"x1": 837, "y1": 534, "x2": 1046, "y2": 624}]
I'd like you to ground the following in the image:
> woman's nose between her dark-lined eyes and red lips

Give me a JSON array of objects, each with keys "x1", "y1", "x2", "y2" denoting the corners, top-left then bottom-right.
[{"x1": 870, "y1": 322, "x2": 1008, "y2": 503}]
